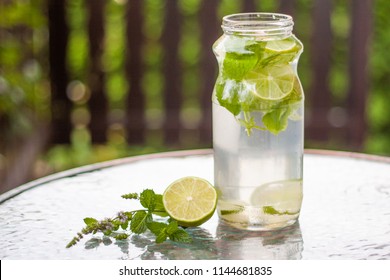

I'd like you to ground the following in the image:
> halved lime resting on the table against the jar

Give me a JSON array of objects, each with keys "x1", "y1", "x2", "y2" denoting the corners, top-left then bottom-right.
[{"x1": 163, "y1": 176, "x2": 217, "y2": 227}]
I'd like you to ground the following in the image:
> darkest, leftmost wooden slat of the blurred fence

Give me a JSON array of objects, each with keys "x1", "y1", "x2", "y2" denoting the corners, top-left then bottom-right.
[{"x1": 47, "y1": 0, "x2": 72, "y2": 143}]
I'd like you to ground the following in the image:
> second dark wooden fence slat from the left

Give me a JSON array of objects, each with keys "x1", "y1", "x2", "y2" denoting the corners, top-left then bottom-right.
[{"x1": 86, "y1": 0, "x2": 108, "y2": 143}]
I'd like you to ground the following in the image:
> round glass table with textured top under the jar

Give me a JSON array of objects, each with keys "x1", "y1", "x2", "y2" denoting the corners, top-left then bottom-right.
[{"x1": 0, "y1": 150, "x2": 390, "y2": 260}]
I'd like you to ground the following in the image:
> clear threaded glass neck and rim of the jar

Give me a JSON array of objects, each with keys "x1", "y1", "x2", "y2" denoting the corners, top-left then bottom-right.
[{"x1": 222, "y1": 13, "x2": 294, "y2": 37}]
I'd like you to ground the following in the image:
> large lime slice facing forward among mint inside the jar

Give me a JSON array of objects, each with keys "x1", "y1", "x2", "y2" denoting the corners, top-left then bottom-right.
[{"x1": 245, "y1": 64, "x2": 295, "y2": 101}]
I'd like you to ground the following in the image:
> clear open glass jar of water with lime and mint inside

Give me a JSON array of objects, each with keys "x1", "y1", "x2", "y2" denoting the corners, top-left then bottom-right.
[{"x1": 212, "y1": 13, "x2": 304, "y2": 230}]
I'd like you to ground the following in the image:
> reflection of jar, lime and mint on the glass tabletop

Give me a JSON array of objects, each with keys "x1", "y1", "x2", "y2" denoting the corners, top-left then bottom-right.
[{"x1": 84, "y1": 222, "x2": 303, "y2": 260}]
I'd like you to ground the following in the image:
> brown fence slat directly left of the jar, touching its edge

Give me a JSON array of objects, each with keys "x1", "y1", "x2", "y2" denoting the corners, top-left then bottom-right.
[{"x1": 198, "y1": 0, "x2": 222, "y2": 144}]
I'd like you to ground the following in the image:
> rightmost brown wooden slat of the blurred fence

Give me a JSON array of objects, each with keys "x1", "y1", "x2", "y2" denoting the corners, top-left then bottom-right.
[{"x1": 347, "y1": 0, "x2": 373, "y2": 149}]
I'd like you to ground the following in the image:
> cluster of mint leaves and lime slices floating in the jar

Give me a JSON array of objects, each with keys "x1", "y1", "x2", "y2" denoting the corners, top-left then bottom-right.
[{"x1": 213, "y1": 35, "x2": 303, "y2": 136}]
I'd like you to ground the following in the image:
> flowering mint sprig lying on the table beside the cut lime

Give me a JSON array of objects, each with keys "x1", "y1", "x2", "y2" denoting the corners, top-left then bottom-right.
[{"x1": 66, "y1": 189, "x2": 192, "y2": 248}]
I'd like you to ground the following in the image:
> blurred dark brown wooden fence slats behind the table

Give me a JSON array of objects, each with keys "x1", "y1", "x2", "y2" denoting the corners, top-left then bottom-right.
[{"x1": 48, "y1": 0, "x2": 372, "y2": 148}]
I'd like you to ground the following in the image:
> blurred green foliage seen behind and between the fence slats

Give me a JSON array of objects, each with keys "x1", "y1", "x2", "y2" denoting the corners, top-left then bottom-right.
[{"x1": 0, "y1": 0, "x2": 390, "y2": 177}]
